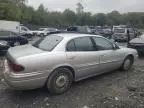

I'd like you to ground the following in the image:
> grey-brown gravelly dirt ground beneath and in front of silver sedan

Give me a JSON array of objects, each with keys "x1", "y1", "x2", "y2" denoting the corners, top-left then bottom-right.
[{"x1": 0, "y1": 57, "x2": 144, "y2": 108}]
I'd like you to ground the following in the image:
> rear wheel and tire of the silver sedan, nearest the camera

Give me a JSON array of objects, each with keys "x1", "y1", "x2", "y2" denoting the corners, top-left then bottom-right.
[{"x1": 46, "y1": 68, "x2": 73, "y2": 94}]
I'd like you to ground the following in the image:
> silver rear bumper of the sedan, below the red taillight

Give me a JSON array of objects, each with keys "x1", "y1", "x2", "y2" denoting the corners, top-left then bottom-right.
[{"x1": 1, "y1": 61, "x2": 47, "y2": 90}]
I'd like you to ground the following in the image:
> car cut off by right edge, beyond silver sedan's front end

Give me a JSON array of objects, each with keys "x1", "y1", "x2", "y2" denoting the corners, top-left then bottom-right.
[{"x1": 128, "y1": 34, "x2": 144, "y2": 55}]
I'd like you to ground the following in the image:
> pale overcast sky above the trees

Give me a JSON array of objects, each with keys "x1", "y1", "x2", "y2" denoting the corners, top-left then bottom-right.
[{"x1": 28, "y1": 0, "x2": 144, "y2": 13}]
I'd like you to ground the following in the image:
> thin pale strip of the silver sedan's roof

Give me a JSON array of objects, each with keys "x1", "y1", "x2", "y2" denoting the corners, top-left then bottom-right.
[{"x1": 53, "y1": 33, "x2": 102, "y2": 38}]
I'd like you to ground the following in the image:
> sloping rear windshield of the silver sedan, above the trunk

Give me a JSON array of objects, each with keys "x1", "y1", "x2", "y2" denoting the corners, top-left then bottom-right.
[{"x1": 33, "y1": 35, "x2": 63, "y2": 51}]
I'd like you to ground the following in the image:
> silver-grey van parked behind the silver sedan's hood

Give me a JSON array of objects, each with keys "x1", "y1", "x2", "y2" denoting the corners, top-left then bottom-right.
[{"x1": 112, "y1": 28, "x2": 135, "y2": 41}]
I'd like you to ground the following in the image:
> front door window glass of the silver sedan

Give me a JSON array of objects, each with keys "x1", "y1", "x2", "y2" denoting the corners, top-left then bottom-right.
[{"x1": 93, "y1": 37, "x2": 113, "y2": 51}]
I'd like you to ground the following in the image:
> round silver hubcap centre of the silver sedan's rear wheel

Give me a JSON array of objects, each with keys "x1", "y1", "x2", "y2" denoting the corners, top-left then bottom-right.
[{"x1": 56, "y1": 75, "x2": 67, "y2": 87}]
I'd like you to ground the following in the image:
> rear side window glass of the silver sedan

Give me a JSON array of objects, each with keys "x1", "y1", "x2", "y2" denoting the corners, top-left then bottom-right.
[{"x1": 68, "y1": 37, "x2": 95, "y2": 51}]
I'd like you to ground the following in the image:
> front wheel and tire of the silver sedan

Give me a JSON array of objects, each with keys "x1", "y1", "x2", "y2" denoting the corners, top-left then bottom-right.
[{"x1": 121, "y1": 56, "x2": 134, "y2": 71}]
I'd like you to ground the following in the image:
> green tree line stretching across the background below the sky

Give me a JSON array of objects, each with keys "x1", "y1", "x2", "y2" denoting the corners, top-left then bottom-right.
[{"x1": 0, "y1": 0, "x2": 144, "y2": 28}]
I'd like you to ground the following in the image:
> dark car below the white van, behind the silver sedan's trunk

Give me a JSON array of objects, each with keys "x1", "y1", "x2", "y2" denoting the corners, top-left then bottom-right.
[{"x1": 0, "y1": 31, "x2": 28, "y2": 47}]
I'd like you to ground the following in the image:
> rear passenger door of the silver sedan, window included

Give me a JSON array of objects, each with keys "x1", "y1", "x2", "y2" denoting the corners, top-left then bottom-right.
[{"x1": 66, "y1": 37, "x2": 99, "y2": 79}]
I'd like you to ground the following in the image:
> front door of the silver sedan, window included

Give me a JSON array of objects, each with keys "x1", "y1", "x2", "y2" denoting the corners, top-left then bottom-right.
[{"x1": 93, "y1": 37, "x2": 123, "y2": 73}]
